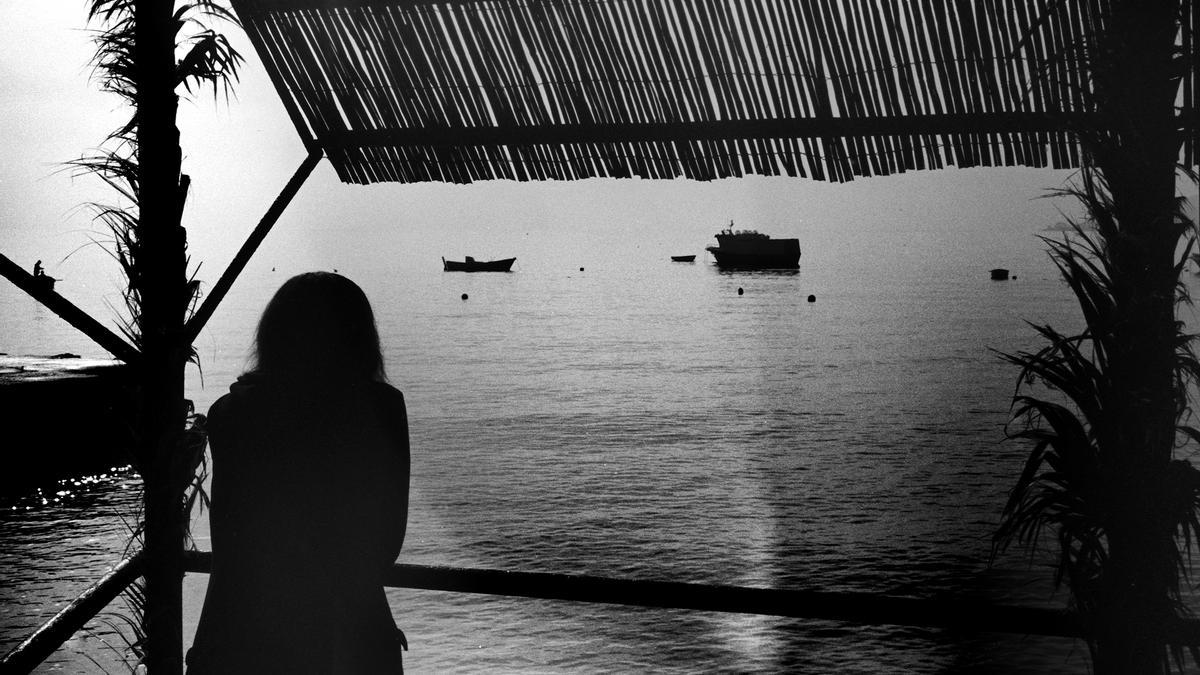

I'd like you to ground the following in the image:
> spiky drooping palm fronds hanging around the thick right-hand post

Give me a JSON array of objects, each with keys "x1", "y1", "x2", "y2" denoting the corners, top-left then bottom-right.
[{"x1": 992, "y1": 135, "x2": 1200, "y2": 669}]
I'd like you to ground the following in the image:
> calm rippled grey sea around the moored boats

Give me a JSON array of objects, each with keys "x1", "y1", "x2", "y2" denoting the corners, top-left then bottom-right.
[{"x1": 0, "y1": 174, "x2": 1190, "y2": 673}]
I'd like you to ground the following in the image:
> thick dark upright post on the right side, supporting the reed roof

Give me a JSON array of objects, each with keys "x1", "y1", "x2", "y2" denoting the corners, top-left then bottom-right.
[{"x1": 1090, "y1": 0, "x2": 1194, "y2": 675}]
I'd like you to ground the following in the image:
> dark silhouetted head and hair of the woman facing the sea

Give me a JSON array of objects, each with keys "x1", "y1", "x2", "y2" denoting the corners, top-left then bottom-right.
[{"x1": 254, "y1": 271, "x2": 384, "y2": 381}]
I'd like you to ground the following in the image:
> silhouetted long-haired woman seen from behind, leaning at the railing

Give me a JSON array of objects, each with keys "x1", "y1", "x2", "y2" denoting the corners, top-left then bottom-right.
[{"x1": 187, "y1": 273, "x2": 409, "y2": 675}]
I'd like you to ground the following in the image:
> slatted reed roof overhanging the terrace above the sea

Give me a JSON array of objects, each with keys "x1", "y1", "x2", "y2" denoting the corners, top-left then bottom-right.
[{"x1": 234, "y1": 0, "x2": 1195, "y2": 183}]
